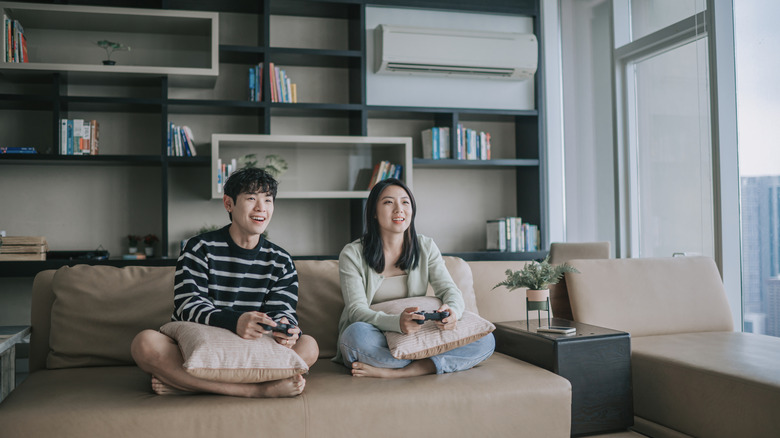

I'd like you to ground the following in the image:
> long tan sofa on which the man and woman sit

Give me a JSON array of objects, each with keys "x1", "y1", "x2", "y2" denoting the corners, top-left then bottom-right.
[{"x1": 0, "y1": 257, "x2": 571, "y2": 438}]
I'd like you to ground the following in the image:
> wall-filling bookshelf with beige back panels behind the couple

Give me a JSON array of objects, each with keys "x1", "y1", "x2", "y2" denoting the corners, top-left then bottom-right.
[{"x1": 0, "y1": 0, "x2": 548, "y2": 269}]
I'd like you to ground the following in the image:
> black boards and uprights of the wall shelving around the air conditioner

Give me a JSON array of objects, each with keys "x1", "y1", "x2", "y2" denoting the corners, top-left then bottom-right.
[{"x1": 0, "y1": 0, "x2": 548, "y2": 271}]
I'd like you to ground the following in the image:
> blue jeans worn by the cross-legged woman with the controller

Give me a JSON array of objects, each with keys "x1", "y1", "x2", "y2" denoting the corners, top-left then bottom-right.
[{"x1": 339, "y1": 322, "x2": 496, "y2": 374}]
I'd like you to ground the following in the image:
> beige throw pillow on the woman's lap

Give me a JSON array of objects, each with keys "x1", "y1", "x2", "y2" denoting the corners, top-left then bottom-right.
[{"x1": 371, "y1": 297, "x2": 496, "y2": 360}]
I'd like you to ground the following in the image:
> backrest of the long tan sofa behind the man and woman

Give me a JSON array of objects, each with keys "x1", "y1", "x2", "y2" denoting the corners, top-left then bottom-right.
[{"x1": 30, "y1": 257, "x2": 500, "y2": 371}]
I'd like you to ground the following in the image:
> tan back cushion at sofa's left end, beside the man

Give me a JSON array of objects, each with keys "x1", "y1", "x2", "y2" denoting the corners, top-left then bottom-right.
[{"x1": 46, "y1": 265, "x2": 174, "y2": 369}]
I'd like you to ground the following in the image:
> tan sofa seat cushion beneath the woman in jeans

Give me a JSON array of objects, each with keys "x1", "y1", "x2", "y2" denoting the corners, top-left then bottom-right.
[{"x1": 303, "y1": 353, "x2": 571, "y2": 438}]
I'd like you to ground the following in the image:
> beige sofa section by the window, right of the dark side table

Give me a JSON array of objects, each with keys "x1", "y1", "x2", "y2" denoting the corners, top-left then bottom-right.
[{"x1": 566, "y1": 257, "x2": 780, "y2": 438}]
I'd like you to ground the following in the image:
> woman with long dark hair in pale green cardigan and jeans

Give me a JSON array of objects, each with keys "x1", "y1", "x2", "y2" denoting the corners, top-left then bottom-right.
[{"x1": 334, "y1": 178, "x2": 495, "y2": 377}]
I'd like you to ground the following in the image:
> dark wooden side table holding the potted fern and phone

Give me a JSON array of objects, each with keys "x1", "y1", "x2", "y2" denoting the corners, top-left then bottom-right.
[{"x1": 493, "y1": 318, "x2": 634, "y2": 436}]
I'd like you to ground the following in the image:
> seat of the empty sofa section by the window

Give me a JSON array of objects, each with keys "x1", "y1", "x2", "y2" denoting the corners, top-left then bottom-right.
[{"x1": 631, "y1": 332, "x2": 780, "y2": 437}]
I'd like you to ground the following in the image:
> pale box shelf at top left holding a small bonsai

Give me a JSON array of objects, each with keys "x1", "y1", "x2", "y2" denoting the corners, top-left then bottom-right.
[{"x1": 0, "y1": 2, "x2": 219, "y2": 86}]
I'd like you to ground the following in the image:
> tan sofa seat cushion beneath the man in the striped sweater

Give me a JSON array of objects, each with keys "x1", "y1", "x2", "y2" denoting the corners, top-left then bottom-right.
[{"x1": 0, "y1": 366, "x2": 306, "y2": 438}]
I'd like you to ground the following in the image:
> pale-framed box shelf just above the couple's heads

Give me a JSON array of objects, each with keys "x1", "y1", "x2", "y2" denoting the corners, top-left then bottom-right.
[{"x1": 211, "y1": 134, "x2": 412, "y2": 199}]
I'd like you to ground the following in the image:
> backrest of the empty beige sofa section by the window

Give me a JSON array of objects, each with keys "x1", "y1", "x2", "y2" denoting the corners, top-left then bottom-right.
[{"x1": 566, "y1": 257, "x2": 734, "y2": 337}]
